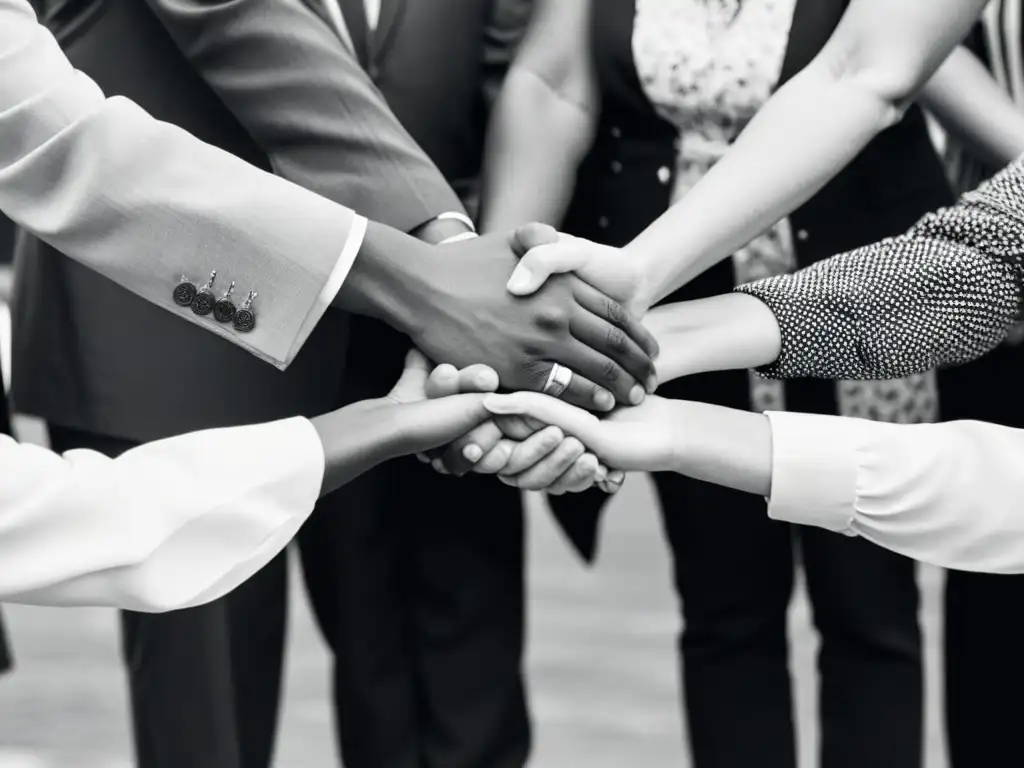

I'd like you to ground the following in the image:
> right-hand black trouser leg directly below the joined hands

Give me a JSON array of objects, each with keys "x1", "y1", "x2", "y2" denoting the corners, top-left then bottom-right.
[{"x1": 403, "y1": 459, "x2": 530, "y2": 768}]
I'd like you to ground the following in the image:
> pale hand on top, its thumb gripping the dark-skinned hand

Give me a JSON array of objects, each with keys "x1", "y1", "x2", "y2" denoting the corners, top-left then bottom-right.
[{"x1": 507, "y1": 233, "x2": 652, "y2": 317}]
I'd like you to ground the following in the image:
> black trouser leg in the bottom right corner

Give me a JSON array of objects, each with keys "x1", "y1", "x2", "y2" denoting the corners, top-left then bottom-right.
[{"x1": 945, "y1": 570, "x2": 1024, "y2": 768}]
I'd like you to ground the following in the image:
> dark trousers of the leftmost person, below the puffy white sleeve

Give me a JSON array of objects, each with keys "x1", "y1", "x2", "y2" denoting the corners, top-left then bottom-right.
[{"x1": 50, "y1": 427, "x2": 287, "y2": 768}]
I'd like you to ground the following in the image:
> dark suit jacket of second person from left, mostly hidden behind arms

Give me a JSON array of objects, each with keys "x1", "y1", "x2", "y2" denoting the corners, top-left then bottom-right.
[{"x1": 317, "y1": 0, "x2": 531, "y2": 400}]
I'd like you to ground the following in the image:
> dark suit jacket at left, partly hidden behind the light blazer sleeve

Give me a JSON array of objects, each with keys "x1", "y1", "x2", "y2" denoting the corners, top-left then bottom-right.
[{"x1": 13, "y1": 0, "x2": 459, "y2": 440}]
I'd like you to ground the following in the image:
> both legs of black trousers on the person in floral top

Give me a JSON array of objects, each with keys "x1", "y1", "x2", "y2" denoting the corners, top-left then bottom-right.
[{"x1": 654, "y1": 374, "x2": 924, "y2": 768}]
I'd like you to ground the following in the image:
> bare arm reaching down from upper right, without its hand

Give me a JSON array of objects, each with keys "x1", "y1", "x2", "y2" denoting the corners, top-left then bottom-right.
[{"x1": 627, "y1": 0, "x2": 985, "y2": 313}]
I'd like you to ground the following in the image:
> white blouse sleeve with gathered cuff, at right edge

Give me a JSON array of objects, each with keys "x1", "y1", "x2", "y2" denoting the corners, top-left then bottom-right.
[{"x1": 768, "y1": 413, "x2": 1024, "y2": 573}]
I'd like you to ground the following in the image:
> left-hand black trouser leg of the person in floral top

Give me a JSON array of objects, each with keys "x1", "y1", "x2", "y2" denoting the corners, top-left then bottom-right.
[{"x1": 654, "y1": 473, "x2": 798, "y2": 768}]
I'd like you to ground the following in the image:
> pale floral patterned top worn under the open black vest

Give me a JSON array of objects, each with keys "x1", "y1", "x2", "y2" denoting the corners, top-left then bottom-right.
[{"x1": 633, "y1": 0, "x2": 938, "y2": 422}]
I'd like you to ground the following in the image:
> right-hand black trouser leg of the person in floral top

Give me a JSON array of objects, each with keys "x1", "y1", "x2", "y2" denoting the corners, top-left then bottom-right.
[{"x1": 799, "y1": 528, "x2": 924, "y2": 768}]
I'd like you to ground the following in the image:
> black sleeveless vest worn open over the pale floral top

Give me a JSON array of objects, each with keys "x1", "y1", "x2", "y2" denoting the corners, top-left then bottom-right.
[{"x1": 551, "y1": 0, "x2": 952, "y2": 559}]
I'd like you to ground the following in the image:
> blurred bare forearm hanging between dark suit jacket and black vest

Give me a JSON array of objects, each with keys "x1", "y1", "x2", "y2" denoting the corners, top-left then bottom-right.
[{"x1": 480, "y1": 66, "x2": 594, "y2": 231}]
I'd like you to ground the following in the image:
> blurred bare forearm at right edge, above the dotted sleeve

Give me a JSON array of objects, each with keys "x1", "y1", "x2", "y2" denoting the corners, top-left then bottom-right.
[{"x1": 921, "y1": 46, "x2": 1024, "y2": 168}]
